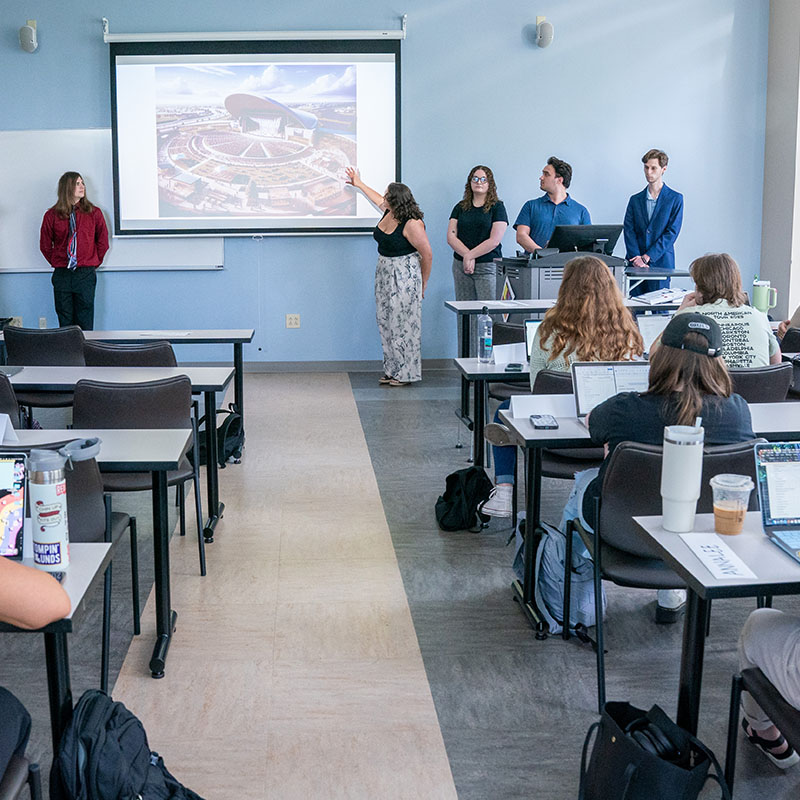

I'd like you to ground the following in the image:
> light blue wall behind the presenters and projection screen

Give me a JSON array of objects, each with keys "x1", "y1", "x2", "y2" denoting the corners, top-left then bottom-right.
[{"x1": 0, "y1": 0, "x2": 769, "y2": 361}]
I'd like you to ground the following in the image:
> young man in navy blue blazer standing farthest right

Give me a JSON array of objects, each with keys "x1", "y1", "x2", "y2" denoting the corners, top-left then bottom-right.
[{"x1": 624, "y1": 150, "x2": 683, "y2": 295}]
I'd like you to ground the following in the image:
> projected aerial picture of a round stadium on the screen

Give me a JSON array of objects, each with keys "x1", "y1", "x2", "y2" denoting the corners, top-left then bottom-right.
[{"x1": 155, "y1": 63, "x2": 357, "y2": 217}]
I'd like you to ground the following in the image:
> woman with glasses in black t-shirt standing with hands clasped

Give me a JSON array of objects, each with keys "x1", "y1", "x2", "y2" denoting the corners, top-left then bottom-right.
[{"x1": 447, "y1": 164, "x2": 508, "y2": 352}]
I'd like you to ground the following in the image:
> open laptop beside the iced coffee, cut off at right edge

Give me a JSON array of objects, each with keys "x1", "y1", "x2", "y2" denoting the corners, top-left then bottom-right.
[{"x1": 755, "y1": 442, "x2": 800, "y2": 562}]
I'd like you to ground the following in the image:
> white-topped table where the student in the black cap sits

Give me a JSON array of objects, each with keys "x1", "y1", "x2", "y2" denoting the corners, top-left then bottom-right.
[{"x1": 500, "y1": 406, "x2": 800, "y2": 639}]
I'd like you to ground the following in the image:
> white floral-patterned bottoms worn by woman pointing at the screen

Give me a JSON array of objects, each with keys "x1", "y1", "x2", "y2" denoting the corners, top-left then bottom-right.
[{"x1": 375, "y1": 253, "x2": 422, "y2": 381}]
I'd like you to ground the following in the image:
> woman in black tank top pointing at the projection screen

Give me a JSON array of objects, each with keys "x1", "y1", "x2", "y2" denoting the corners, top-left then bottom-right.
[{"x1": 345, "y1": 167, "x2": 433, "y2": 386}]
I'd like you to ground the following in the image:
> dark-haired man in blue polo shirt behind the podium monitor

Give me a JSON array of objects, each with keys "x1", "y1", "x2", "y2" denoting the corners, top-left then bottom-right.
[{"x1": 514, "y1": 156, "x2": 592, "y2": 253}]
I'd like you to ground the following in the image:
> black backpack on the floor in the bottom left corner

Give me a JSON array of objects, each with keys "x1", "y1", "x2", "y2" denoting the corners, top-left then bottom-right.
[{"x1": 50, "y1": 690, "x2": 203, "y2": 800}]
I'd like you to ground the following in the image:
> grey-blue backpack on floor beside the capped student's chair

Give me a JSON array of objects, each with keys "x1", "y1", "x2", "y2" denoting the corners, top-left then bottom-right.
[{"x1": 514, "y1": 519, "x2": 606, "y2": 634}]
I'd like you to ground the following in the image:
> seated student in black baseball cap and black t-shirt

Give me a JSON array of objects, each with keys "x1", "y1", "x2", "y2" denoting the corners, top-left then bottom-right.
[{"x1": 561, "y1": 313, "x2": 755, "y2": 622}]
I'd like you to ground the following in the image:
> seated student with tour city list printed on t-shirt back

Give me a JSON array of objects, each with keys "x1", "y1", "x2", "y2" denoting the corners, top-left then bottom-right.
[{"x1": 651, "y1": 253, "x2": 781, "y2": 369}]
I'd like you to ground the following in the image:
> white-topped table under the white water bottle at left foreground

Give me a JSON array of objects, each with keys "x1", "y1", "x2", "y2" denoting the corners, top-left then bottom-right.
[{"x1": 0, "y1": 542, "x2": 111, "y2": 753}]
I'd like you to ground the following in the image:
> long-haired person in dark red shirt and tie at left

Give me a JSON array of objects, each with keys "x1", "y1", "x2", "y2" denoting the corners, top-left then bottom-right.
[{"x1": 39, "y1": 172, "x2": 108, "y2": 331}]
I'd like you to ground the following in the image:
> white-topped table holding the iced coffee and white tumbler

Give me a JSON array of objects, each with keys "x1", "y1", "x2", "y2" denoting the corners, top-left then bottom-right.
[{"x1": 634, "y1": 511, "x2": 800, "y2": 734}]
